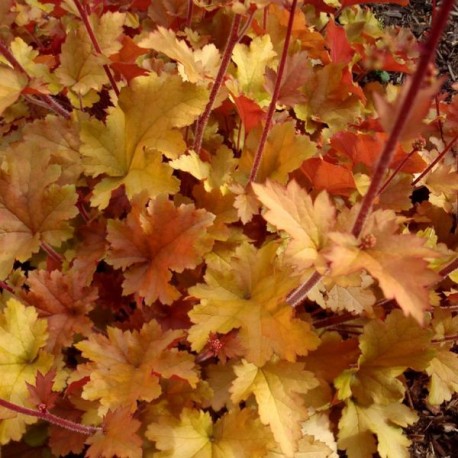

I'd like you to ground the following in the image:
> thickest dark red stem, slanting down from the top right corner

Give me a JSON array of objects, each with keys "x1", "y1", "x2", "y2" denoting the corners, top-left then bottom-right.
[{"x1": 352, "y1": 0, "x2": 454, "y2": 237}]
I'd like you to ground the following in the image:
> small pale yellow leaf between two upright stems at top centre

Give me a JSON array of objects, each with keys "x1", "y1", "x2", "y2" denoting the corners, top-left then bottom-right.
[{"x1": 232, "y1": 35, "x2": 277, "y2": 106}]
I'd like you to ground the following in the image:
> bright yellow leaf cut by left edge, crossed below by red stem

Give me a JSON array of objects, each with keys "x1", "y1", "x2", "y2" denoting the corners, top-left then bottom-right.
[{"x1": 0, "y1": 299, "x2": 54, "y2": 444}]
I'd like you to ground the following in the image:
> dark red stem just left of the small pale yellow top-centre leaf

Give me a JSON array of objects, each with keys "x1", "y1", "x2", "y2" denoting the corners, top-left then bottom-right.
[{"x1": 193, "y1": 14, "x2": 242, "y2": 153}]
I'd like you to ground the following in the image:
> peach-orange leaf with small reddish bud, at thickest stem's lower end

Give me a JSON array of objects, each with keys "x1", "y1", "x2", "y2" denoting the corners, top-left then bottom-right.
[{"x1": 326, "y1": 210, "x2": 439, "y2": 323}]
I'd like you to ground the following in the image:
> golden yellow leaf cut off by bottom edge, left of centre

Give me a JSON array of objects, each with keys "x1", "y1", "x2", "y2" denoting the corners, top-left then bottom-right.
[{"x1": 146, "y1": 408, "x2": 272, "y2": 458}]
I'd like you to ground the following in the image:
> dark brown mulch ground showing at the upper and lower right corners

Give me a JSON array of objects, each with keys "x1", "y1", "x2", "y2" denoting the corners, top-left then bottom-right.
[{"x1": 373, "y1": 0, "x2": 458, "y2": 458}]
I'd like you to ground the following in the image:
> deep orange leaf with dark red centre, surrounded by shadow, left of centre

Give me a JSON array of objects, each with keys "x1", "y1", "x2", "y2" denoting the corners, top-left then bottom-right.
[{"x1": 106, "y1": 195, "x2": 215, "y2": 304}]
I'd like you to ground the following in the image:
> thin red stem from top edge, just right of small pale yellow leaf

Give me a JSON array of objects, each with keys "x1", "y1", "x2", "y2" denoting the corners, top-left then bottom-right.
[{"x1": 248, "y1": 0, "x2": 297, "y2": 183}]
